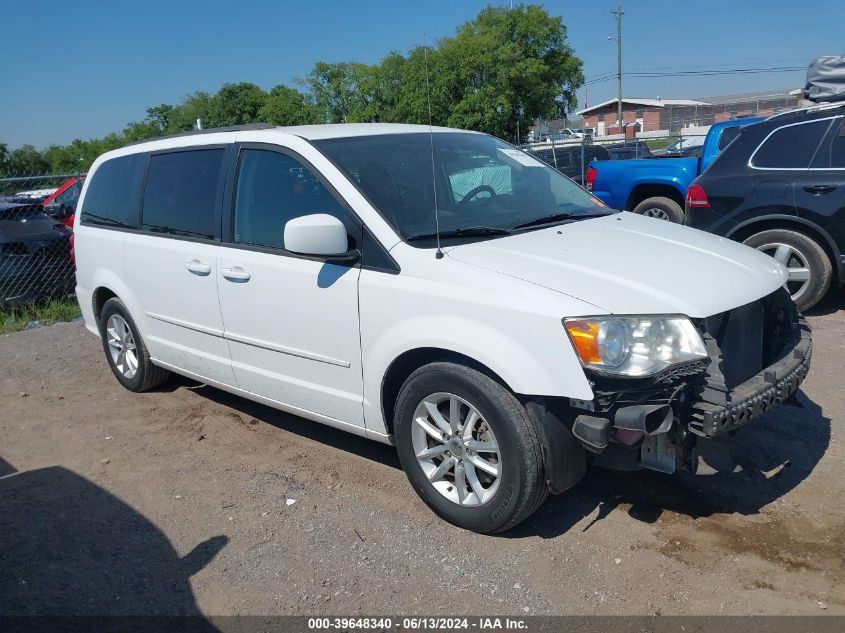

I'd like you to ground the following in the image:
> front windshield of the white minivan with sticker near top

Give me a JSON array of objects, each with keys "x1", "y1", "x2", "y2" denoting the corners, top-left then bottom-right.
[{"x1": 314, "y1": 132, "x2": 609, "y2": 240}]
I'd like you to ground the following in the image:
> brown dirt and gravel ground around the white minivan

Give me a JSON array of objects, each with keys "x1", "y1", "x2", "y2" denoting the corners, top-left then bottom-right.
[{"x1": 0, "y1": 296, "x2": 845, "y2": 615}]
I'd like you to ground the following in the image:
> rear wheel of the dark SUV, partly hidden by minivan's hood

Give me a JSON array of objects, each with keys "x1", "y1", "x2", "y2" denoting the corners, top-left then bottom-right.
[{"x1": 743, "y1": 229, "x2": 833, "y2": 312}]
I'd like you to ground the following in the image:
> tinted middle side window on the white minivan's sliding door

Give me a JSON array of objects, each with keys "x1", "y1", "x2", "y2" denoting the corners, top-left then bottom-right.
[{"x1": 142, "y1": 148, "x2": 225, "y2": 239}]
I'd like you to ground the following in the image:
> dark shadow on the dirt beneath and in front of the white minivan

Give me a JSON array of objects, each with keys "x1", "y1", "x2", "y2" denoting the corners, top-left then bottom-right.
[{"x1": 182, "y1": 381, "x2": 830, "y2": 538}]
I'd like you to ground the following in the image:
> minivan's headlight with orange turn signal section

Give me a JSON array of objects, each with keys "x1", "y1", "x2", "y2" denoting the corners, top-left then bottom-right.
[{"x1": 563, "y1": 316, "x2": 707, "y2": 376}]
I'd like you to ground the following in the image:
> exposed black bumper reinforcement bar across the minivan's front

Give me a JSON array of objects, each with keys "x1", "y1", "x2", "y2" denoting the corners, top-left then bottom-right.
[{"x1": 689, "y1": 318, "x2": 813, "y2": 437}]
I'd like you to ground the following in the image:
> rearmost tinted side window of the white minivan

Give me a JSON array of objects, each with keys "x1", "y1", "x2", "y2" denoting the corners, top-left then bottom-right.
[{"x1": 79, "y1": 154, "x2": 147, "y2": 229}]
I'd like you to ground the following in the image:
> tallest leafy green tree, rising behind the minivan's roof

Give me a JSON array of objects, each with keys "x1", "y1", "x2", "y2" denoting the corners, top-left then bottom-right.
[{"x1": 390, "y1": 5, "x2": 584, "y2": 139}]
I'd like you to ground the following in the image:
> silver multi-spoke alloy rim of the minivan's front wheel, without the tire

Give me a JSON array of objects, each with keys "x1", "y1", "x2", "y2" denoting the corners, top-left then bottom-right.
[{"x1": 411, "y1": 392, "x2": 501, "y2": 506}]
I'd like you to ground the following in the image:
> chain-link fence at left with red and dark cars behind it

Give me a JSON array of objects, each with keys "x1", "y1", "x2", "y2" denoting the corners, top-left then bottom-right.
[{"x1": 0, "y1": 174, "x2": 84, "y2": 311}]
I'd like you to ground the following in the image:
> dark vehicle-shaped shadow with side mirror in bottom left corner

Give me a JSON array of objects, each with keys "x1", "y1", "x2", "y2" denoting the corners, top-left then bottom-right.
[{"x1": 0, "y1": 460, "x2": 228, "y2": 631}]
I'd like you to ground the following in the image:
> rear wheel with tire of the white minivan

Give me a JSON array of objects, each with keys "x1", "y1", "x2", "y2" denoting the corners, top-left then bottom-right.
[{"x1": 99, "y1": 297, "x2": 170, "y2": 392}]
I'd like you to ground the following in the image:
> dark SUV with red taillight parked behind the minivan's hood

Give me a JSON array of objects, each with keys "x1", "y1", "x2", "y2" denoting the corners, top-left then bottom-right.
[{"x1": 686, "y1": 103, "x2": 845, "y2": 310}]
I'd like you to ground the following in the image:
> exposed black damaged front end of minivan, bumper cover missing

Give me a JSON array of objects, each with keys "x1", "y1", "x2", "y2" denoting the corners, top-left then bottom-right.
[{"x1": 570, "y1": 293, "x2": 812, "y2": 473}]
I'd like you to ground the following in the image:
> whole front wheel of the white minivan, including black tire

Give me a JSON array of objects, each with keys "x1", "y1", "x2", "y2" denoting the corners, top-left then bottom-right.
[{"x1": 394, "y1": 362, "x2": 549, "y2": 534}]
